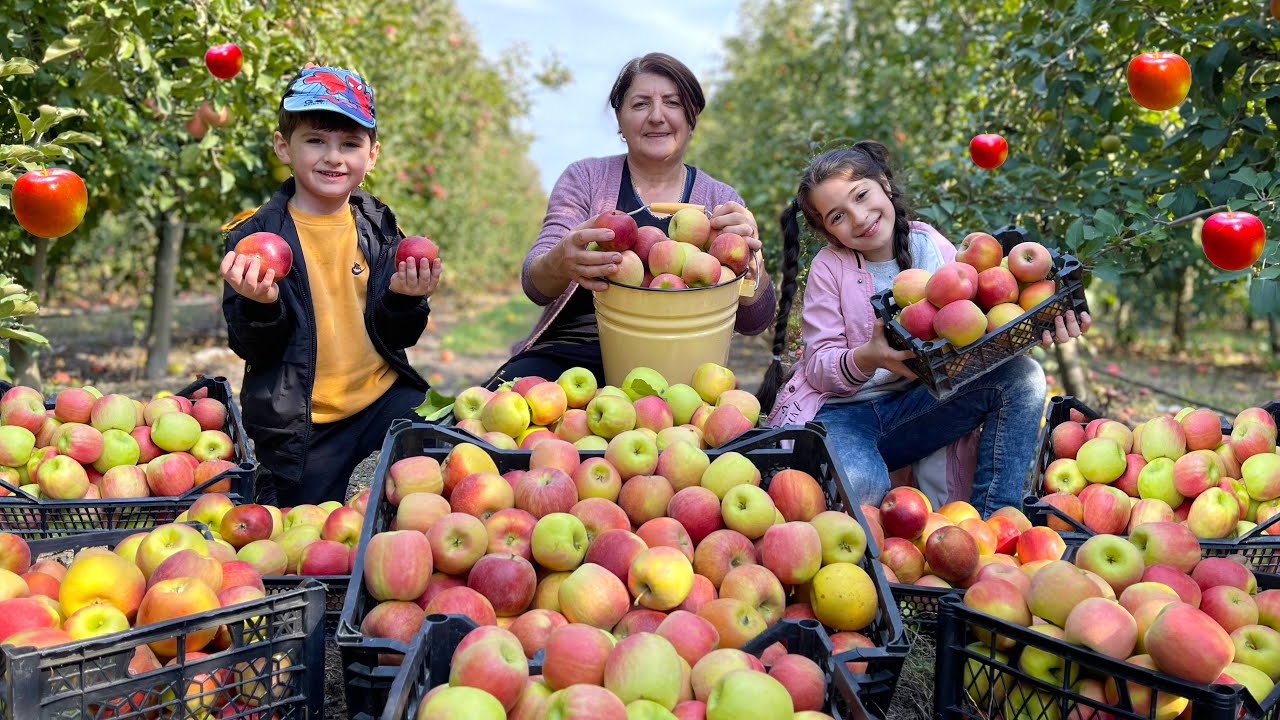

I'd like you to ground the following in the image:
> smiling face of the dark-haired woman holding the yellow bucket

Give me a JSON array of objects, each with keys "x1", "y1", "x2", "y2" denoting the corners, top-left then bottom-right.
[{"x1": 617, "y1": 73, "x2": 690, "y2": 161}]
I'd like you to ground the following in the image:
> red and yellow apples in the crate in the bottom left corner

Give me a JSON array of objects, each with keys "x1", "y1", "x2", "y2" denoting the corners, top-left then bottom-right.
[{"x1": 0, "y1": 524, "x2": 304, "y2": 717}]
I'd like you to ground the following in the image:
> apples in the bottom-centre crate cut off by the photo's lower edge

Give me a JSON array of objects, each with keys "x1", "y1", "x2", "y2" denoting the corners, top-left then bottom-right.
[{"x1": 401, "y1": 610, "x2": 831, "y2": 720}]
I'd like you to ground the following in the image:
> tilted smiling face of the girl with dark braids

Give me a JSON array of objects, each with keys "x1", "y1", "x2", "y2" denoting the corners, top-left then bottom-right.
[{"x1": 809, "y1": 177, "x2": 897, "y2": 263}]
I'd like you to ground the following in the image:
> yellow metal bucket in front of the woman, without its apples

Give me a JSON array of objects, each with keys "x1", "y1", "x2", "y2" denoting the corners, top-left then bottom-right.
[{"x1": 594, "y1": 258, "x2": 755, "y2": 386}]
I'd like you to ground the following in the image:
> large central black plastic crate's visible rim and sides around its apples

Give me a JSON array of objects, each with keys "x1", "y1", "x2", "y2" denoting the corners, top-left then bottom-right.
[{"x1": 335, "y1": 421, "x2": 910, "y2": 717}]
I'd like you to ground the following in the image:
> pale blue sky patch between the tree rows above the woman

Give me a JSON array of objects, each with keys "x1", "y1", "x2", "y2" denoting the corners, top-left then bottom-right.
[{"x1": 458, "y1": 0, "x2": 739, "y2": 191}]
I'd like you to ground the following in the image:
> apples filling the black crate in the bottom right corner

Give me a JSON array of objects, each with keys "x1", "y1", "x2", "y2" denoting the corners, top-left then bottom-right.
[{"x1": 964, "y1": 521, "x2": 1280, "y2": 717}]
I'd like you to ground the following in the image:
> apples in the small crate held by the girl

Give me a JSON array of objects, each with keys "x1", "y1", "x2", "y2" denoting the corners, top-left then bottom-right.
[{"x1": 893, "y1": 232, "x2": 1057, "y2": 347}]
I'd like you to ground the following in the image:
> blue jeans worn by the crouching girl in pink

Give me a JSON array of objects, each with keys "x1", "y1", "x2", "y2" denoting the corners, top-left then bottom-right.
[{"x1": 814, "y1": 355, "x2": 1046, "y2": 518}]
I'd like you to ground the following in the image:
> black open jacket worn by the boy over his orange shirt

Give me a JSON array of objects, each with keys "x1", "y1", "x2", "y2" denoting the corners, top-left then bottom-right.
[{"x1": 223, "y1": 179, "x2": 430, "y2": 484}]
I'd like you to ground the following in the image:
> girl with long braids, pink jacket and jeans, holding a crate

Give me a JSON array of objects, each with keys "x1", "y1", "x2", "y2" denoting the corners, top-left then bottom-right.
[{"x1": 759, "y1": 141, "x2": 1089, "y2": 518}]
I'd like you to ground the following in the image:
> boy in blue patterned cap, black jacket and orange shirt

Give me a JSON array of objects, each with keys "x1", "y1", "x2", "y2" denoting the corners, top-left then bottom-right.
[{"x1": 220, "y1": 67, "x2": 440, "y2": 507}]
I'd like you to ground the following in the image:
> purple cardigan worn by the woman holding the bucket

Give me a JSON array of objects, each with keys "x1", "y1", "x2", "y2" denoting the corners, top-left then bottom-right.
[{"x1": 513, "y1": 155, "x2": 776, "y2": 352}]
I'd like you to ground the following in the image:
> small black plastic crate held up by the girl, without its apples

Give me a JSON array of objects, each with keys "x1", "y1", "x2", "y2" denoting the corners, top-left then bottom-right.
[{"x1": 872, "y1": 228, "x2": 1089, "y2": 400}]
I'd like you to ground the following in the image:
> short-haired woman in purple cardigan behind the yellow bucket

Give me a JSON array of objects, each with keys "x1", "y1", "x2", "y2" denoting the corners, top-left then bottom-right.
[{"x1": 489, "y1": 53, "x2": 774, "y2": 387}]
